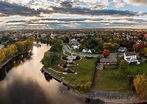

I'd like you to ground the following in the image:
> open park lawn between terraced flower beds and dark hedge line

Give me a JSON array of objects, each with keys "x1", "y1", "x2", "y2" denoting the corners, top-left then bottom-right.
[{"x1": 65, "y1": 58, "x2": 96, "y2": 84}]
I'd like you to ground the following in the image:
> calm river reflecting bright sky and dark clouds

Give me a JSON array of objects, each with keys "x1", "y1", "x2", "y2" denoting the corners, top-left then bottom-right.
[{"x1": 0, "y1": 44, "x2": 88, "y2": 104}]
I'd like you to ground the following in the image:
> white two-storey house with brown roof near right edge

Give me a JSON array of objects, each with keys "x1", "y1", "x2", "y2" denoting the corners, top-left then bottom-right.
[{"x1": 124, "y1": 52, "x2": 140, "y2": 64}]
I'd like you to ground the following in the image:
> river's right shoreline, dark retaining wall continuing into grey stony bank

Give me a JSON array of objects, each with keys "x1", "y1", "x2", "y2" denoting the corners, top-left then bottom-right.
[{"x1": 41, "y1": 68, "x2": 147, "y2": 104}]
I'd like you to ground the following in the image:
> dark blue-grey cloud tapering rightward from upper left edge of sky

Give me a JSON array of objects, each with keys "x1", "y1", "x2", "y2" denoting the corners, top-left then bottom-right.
[{"x1": 0, "y1": 1, "x2": 42, "y2": 16}]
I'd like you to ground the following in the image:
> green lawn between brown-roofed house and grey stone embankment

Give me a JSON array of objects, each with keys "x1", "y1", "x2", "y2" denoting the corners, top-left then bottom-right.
[{"x1": 93, "y1": 69, "x2": 130, "y2": 91}]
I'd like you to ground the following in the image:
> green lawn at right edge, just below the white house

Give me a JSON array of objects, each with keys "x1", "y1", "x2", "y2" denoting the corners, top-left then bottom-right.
[{"x1": 128, "y1": 62, "x2": 147, "y2": 75}]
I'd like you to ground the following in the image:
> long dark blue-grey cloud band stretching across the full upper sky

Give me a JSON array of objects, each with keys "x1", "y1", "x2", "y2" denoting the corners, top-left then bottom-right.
[{"x1": 0, "y1": 0, "x2": 143, "y2": 16}]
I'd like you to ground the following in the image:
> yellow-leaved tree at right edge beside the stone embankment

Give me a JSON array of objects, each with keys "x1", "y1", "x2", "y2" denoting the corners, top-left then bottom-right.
[{"x1": 133, "y1": 75, "x2": 147, "y2": 99}]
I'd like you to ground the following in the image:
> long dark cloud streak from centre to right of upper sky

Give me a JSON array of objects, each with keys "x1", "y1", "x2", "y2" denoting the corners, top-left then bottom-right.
[{"x1": 51, "y1": 2, "x2": 138, "y2": 16}]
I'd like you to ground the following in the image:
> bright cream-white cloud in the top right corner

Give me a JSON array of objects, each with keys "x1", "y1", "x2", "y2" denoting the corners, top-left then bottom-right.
[{"x1": 124, "y1": 0, "x2": 147, "y2": 6}]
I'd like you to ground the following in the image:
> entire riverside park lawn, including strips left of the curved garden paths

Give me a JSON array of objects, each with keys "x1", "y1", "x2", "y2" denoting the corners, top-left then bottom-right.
[{"x1": 49, "y1": 58, "x2": 96, "y2": 85}]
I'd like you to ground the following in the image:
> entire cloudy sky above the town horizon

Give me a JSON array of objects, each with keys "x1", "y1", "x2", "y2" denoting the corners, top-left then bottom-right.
[{"x1": 0, "y1": 0, "x2": 147, "y2": 30}]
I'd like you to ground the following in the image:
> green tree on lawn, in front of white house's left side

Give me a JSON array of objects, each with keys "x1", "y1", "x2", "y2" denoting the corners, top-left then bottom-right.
[{"x1": 118, "y1": 60, "x2": 129, "y2": 76}]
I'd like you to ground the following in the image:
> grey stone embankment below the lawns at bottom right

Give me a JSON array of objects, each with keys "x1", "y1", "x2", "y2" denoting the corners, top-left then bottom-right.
[{"x1": 88, "y1": 90, "x2": 147, "y2": 104}]
